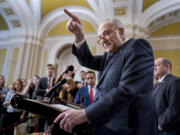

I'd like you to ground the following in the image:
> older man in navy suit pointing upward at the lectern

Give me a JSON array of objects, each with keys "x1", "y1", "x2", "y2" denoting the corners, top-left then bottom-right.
[{"x1": 54, "y1": 10, "x2": 157, "y2": 135}]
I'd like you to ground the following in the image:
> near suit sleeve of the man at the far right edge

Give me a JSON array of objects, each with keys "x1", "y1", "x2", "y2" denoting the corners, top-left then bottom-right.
[{"x1": 158, "y1": 79, "x2": 180, "y2": 130}]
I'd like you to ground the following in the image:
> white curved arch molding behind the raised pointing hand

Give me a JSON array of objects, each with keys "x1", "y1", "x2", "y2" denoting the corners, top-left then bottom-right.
[{"x1": 39, "y1": 6, "x2": 99, "y2": 37}]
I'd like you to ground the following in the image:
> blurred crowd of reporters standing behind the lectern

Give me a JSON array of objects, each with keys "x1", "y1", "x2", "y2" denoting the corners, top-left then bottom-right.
[{"x1": 0, "y1": 64, "x2": 96, "y2": 135}]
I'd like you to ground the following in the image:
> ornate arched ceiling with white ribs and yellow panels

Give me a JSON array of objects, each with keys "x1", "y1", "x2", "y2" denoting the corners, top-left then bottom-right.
[{"x1": 0, "y1": 0, "x2": 180, "y2": 37}]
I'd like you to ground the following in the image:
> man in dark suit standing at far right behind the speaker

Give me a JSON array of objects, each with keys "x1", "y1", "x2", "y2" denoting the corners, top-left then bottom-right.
[{"x1": 154, "y1": 58, "x2": 180, "y2": 135}]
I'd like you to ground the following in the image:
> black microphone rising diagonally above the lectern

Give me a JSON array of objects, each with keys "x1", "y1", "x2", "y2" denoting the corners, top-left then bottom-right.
[{"x1": 43, "y1": 79, "x2": 67, "y2": 98}]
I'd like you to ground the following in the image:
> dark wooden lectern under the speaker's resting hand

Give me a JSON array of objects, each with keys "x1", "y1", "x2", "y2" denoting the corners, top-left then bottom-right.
[{"x1": 11, "y1": 94, "x2": 93, "y2": 135}]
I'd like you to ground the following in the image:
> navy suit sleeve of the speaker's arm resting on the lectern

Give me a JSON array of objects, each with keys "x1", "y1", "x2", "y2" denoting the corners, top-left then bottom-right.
[{"x1": 85, "y1": 39, "x2": 154, "y2": 121}]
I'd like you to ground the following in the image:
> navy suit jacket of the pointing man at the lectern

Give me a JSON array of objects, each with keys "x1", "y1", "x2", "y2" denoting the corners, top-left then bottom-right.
[{"x1": 72, "y1": 39, "x2": 157, "y2": 135}]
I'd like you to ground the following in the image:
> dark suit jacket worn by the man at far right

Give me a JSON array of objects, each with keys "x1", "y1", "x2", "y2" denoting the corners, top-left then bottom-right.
[{"x1": 155, "y1": 74, "x2": 180, "y2": 135}]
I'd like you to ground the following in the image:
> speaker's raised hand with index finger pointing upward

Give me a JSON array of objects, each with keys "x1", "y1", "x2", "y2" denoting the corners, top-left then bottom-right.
[{"x1": 64, "y1": 9, "x2": 84, "y2": 43}]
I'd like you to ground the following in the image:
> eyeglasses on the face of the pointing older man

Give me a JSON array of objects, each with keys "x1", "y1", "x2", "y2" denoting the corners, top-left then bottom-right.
[{"x1": 97, "y1": 28, "x2": 116, "y2": 45}]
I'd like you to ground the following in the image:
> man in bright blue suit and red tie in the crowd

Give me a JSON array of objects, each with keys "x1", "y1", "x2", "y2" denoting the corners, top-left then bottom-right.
[{"x1": 74, "y1": 71, "x2": 96, "y2": 107}]
